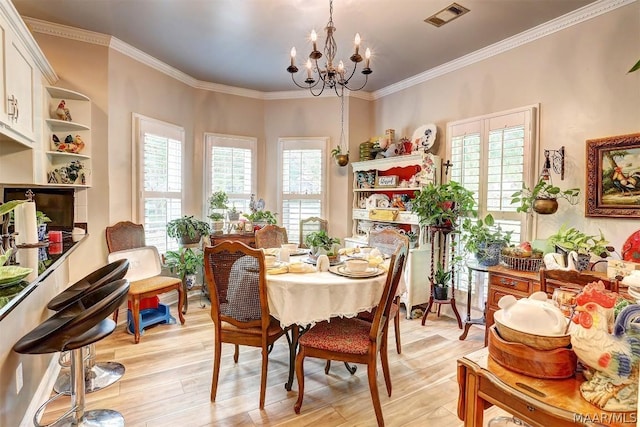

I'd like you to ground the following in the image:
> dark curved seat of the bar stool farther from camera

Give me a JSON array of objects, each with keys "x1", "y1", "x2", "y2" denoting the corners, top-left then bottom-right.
[{"x1": 47, "y1": 259, "x2": 129, "y2": 311}]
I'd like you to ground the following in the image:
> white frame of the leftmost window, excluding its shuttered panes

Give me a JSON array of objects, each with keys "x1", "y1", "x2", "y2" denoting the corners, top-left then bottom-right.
[{"x1": 131, "y1": 113, "x2": 185, "y2": 254}]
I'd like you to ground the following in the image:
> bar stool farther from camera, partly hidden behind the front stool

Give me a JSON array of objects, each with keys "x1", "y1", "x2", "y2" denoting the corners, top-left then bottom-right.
[{"x1": 47, "y1": 259, "x2": 129, "y2": 394}]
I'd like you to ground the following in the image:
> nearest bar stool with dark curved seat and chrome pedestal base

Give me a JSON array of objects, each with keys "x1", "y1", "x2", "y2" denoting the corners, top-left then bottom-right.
[{"x1": 13, "y1": 279, "x2": 129, "y2": 427}]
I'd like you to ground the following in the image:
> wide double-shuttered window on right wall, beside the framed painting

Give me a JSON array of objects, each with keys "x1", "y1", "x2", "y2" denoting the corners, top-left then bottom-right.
[{"x1": 447, "y1": 106, "x2": 538, "y2": 298}]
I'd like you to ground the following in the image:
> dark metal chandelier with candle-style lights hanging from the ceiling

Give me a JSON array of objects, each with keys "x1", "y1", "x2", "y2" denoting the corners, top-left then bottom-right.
[{"x1": 287, "y1": 0, "x2": 373, "y2": 97}]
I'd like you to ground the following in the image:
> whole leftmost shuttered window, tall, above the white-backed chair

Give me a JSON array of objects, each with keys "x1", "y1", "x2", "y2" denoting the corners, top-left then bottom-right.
[{"x1": 133, "y1": 114, "x2": 184, "y2": 253}]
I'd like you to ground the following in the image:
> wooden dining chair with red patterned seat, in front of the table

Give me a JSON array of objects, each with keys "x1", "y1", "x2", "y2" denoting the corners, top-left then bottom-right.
[{"x1": 294, "y1": 245, "x2": 407, "y2": 426}]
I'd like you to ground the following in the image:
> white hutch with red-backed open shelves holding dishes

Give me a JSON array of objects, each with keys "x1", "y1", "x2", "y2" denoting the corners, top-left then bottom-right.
[{"x1": 345, "y1": 154, "x2": 441, "y2": 318}]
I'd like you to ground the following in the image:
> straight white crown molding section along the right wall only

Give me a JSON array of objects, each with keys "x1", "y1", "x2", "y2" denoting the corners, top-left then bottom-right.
[{"x1": 373, "y1": 0, "x2": 637, "y2": 99}]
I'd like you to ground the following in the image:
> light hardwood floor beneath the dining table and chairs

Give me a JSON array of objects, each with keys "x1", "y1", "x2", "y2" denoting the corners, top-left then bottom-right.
[{"x1": 42, "y1": 293, "x2": 504, "y2": 427}]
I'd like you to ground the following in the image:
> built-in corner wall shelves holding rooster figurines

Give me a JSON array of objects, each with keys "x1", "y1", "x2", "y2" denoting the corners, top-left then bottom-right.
[{"x1": 44, "y1": 86, "x2": 91, "y2": 188}]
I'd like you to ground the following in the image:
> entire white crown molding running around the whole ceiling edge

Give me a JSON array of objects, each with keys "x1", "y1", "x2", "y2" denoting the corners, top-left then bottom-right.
[{"x1": 22, "y1": 0, "x2": 637, "y2": 101}]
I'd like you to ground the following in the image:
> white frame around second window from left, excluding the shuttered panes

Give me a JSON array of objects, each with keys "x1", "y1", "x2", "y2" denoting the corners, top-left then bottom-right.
[{"x1": 202, "y1": 132, "x2": 258, "y2": 218}]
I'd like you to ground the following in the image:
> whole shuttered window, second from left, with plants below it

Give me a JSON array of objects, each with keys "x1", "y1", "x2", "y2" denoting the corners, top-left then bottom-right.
[{"x1": 203, "y1": 133, "x2": 257, "y2": 216}]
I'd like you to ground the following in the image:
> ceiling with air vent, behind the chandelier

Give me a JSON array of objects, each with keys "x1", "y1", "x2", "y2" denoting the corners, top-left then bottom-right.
[{"x1": 12, "y1": 0, "x2": 594, "y2": 92}]
